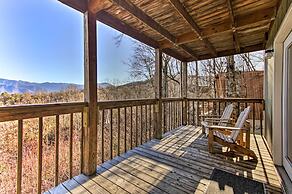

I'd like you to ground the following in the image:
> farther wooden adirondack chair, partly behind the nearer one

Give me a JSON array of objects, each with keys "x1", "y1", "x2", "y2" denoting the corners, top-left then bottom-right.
[{"x1": 201, "y1": 104, "x2": 233, "y2": 133}]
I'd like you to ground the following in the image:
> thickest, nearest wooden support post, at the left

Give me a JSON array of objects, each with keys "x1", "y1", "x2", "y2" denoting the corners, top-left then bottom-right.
[{"x1": 82, "y1": 11, "x2": 98, "y2": 175}]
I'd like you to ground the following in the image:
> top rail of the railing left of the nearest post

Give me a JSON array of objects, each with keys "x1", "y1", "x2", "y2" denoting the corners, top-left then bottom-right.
[{"x1": 0, "y1": 102, "x2": 88, "y2": 122}]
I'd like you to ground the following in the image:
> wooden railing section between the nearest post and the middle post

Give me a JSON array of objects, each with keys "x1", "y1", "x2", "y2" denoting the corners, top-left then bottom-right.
[{"x1": 97, "y1": 99, "x2": 157, "y2": 163}]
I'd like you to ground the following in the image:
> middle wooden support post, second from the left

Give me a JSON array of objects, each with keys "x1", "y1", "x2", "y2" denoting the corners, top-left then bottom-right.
[{"x1": 155, "y1": 49, "x2": 163, "y2": 139}]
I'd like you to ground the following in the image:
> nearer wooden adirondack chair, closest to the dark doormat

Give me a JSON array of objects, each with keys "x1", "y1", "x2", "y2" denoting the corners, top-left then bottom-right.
[{"x1": 208, "y1": 106, "x2": 257, "y2": 160}]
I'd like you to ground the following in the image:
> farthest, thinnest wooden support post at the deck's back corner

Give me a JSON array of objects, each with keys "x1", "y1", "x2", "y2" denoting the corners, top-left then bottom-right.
[{"x1": 180, "y1": 62, "x2": 188, "y2": 125}]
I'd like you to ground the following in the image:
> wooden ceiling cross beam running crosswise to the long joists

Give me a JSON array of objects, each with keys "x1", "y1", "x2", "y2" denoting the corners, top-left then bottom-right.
[{"x1": 159, "y1": 8, "x2": 273, "y2": 48}]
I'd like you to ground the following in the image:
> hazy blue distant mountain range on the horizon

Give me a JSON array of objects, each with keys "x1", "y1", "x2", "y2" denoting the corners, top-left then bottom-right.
[{"x1": 0, "y1": 78, "x2": 112, "y2": 94}]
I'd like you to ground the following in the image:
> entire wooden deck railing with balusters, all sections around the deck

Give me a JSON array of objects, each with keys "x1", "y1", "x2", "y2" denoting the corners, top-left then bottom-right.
[{"x1": 0, "y1": 98, "x2": 264, "y2": 193}]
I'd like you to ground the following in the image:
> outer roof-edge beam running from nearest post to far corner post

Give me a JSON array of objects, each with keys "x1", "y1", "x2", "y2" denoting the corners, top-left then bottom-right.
[{"x1": 96, "y1": 11, "x2": 186, "y2": 61}]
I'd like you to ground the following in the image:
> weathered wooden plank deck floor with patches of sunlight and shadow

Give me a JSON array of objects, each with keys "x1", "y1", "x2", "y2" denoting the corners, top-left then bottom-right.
[{"x1": 47, "y1": 126, "x2": 282, "y2": 194}]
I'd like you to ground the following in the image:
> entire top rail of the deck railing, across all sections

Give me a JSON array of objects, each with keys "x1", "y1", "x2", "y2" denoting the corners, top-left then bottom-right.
[{"x1": 0, "y1": 98, "x2": 264, "y2": 122}]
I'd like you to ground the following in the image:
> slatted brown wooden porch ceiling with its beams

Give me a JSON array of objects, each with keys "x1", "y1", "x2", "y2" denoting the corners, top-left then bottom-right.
[{"x1": 59, "y1": 0, "x2": 280, "y2": 62}]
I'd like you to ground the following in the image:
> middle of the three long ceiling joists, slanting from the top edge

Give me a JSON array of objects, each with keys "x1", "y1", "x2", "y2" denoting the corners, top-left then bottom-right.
[{"x1": 169, "y1": 0, "x2": 217, "y2": 57}]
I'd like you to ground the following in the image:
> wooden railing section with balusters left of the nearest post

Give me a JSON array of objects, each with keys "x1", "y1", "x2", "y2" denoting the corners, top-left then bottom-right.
[{"x1": 0, "y1": 103, "x2": 87, "y2": 193}]
